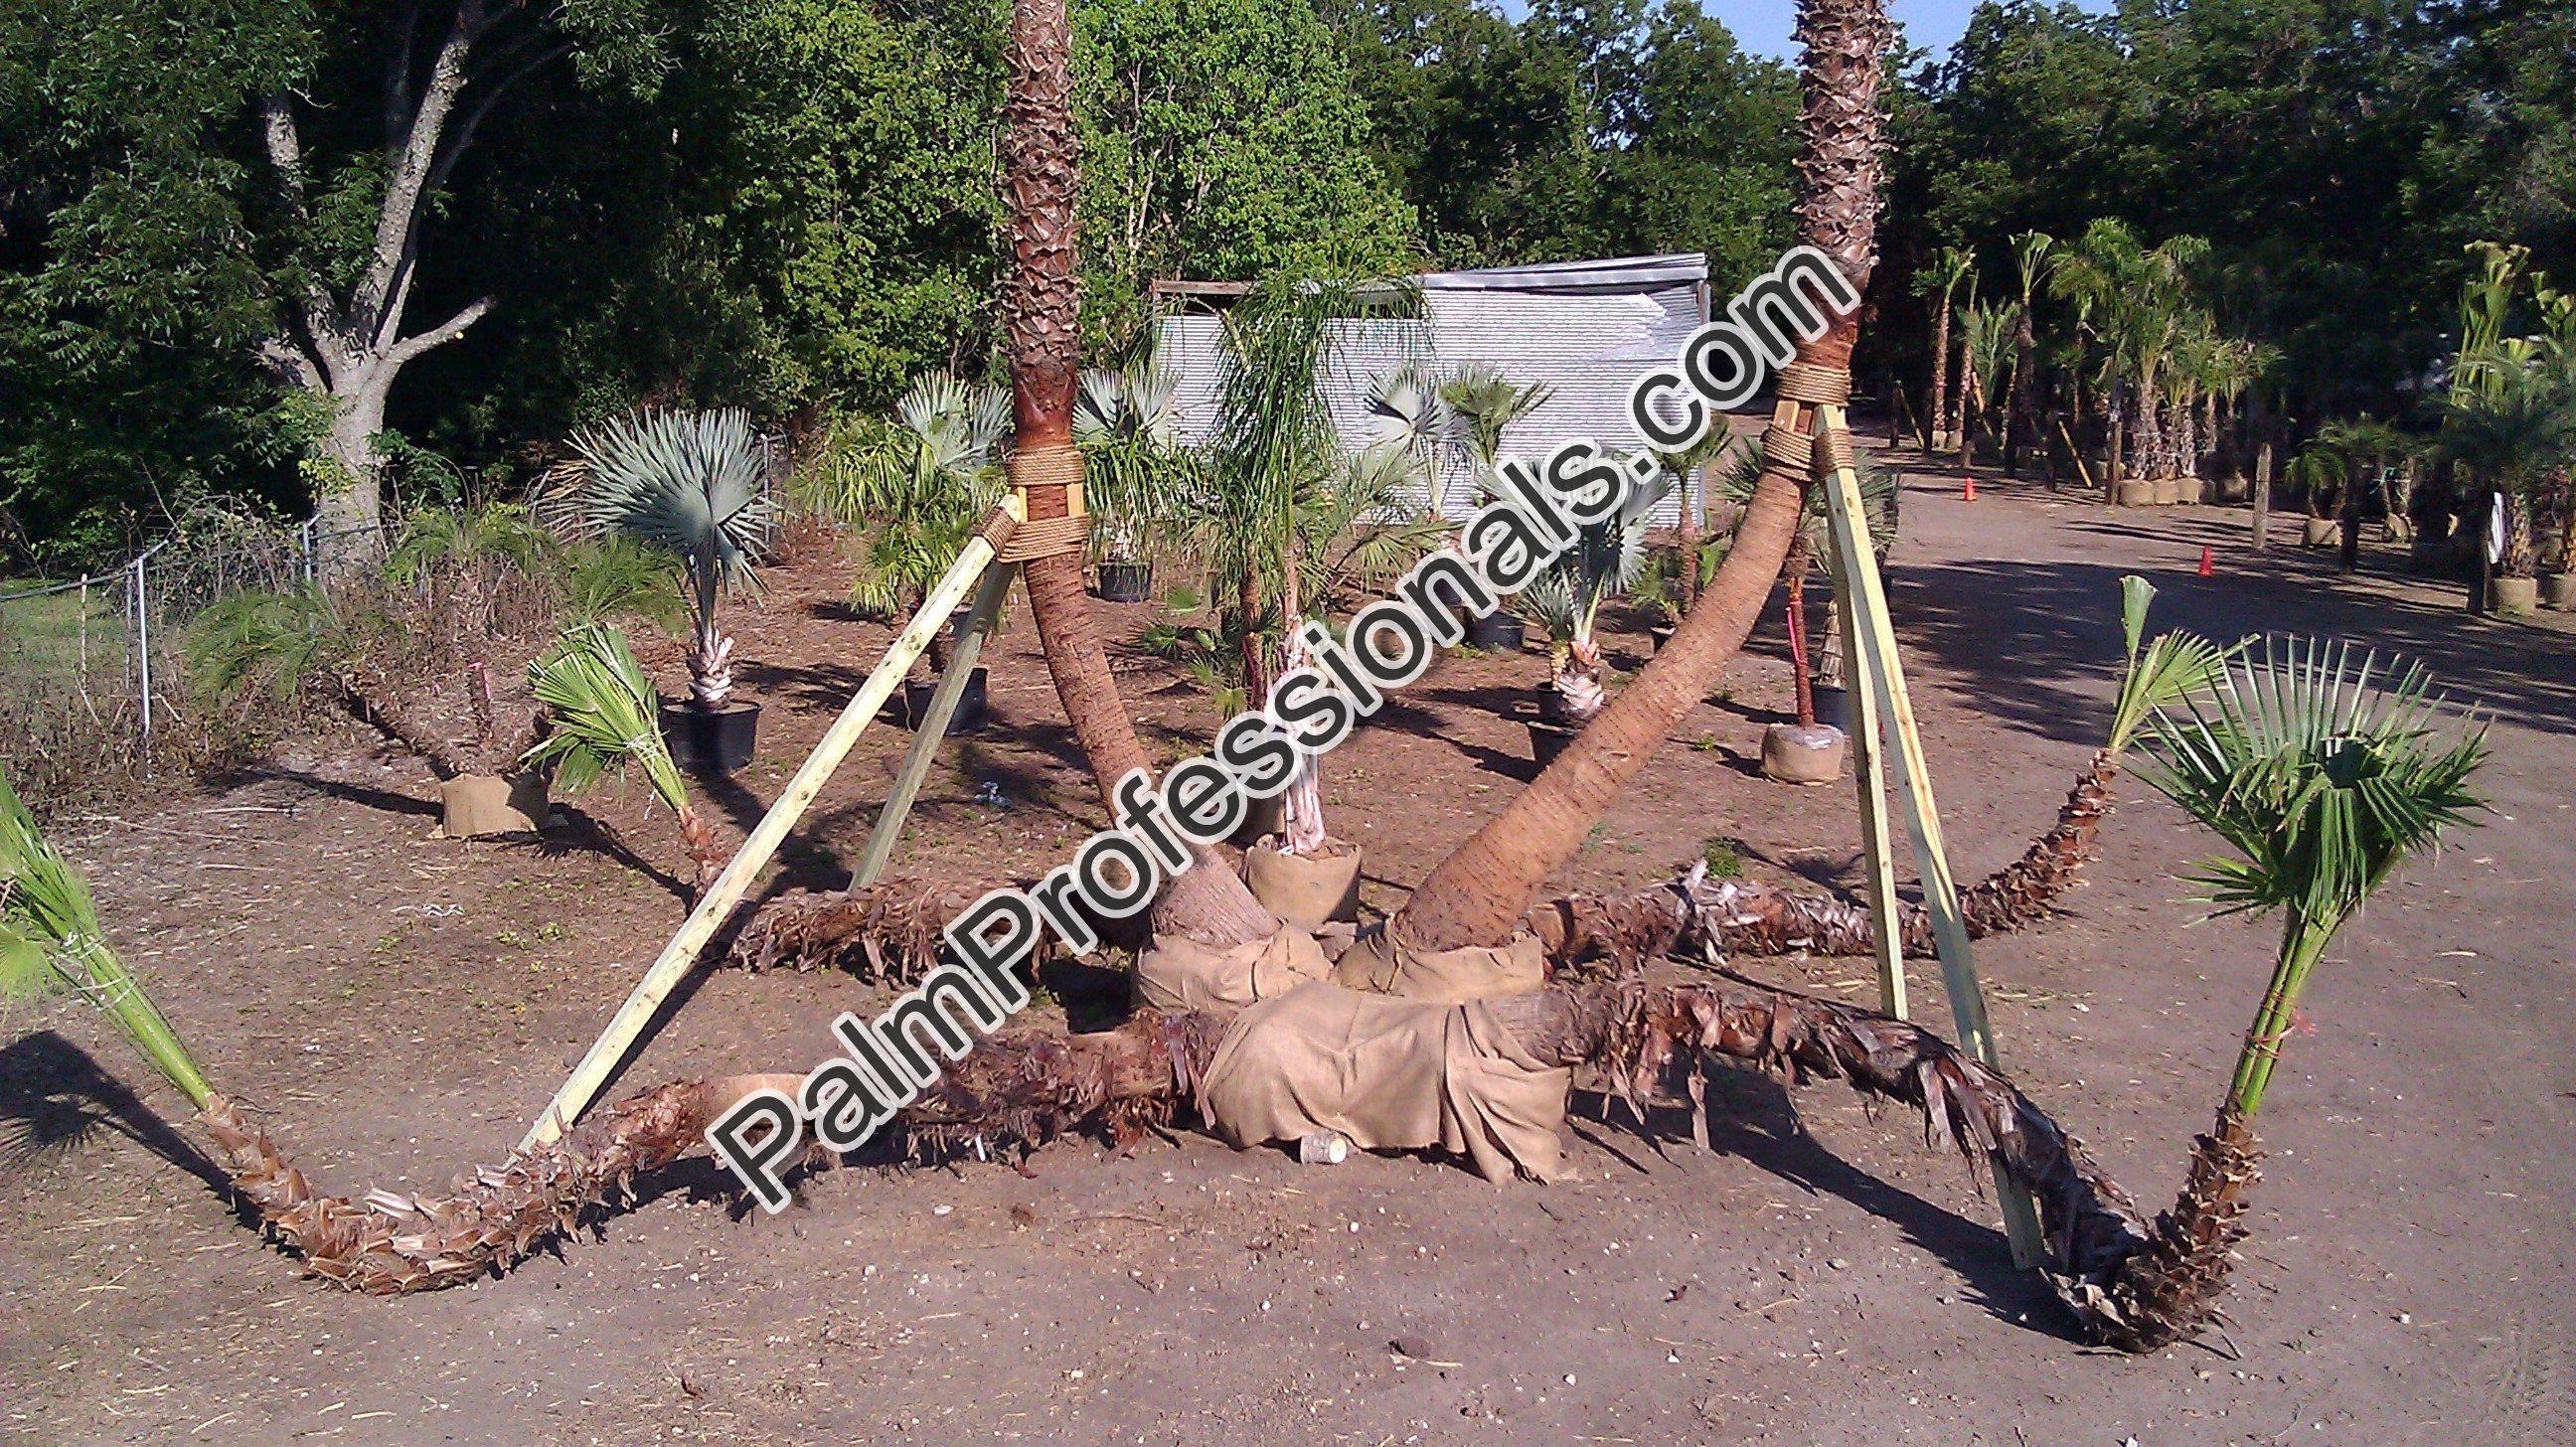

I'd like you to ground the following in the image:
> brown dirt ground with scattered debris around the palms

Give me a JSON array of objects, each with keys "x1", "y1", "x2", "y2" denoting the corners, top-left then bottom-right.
[{"x1": 0, "y1": 447, "x2": 2576, "y2": 1447}]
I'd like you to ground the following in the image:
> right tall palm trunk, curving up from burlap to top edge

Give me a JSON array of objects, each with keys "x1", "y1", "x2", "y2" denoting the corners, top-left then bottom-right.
[{"x1": 1388, "y1": 0, "x2": 1891, "y2": 950}]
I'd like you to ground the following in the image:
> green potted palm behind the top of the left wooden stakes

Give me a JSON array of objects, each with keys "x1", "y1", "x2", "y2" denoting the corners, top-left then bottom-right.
[{"x1": 809, "y1": 371, "x2": 1010, "y2": 733}]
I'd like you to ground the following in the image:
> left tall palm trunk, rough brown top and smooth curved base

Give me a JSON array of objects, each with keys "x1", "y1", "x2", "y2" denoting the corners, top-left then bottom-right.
[{"x1": 1002, "y1": 0, "x2": 1278, "y2": 945}]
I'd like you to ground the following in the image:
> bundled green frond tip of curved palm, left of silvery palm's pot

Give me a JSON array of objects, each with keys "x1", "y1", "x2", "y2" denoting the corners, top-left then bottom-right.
[{"x1": 521, "y1": 623, "x2": 724, "y2": 893}]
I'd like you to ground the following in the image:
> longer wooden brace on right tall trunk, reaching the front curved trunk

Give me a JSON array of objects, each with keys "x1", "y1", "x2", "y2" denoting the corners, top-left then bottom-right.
[{"x1": 1816, "y1": 406, "x2": 2048, "y2": 1269}]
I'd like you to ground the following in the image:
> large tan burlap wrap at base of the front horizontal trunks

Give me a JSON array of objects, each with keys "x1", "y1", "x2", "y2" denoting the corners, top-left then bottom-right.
[{"x1": 1198, "y1": 981, "x2": 1574, "y2": 1182}]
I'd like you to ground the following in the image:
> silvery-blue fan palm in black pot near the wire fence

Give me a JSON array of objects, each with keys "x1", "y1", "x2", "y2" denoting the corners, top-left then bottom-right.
[{"x1": 571, "y1": 406, "x2": 775, "y2": 772}]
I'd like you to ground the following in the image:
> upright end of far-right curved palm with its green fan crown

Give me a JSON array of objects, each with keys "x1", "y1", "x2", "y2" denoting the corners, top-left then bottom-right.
[{"x1": 2079, "y1": 639, "x2": 2486, "y2": 1350}]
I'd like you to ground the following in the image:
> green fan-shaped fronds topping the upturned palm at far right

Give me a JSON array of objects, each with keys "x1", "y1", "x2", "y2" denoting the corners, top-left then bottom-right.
[{"x1": 2141, "y1": 639, "x2": 2486, "y2": 932}]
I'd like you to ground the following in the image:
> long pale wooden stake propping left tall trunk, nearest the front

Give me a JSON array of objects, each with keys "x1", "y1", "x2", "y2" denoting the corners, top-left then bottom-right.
[{"x1": 518, "y1": 497, "x2": 1020, "y2": 1151}]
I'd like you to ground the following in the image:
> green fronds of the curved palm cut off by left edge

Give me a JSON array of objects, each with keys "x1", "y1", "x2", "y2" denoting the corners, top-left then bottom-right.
[{"x1": 0, "y1": 777, "x2": 214, "y2": 1104}]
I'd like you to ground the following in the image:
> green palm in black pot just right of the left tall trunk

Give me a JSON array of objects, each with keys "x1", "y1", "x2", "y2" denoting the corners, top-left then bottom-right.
[{"x1": 1074, "y1": 347, "x2": 1180, "y2": 602}]
